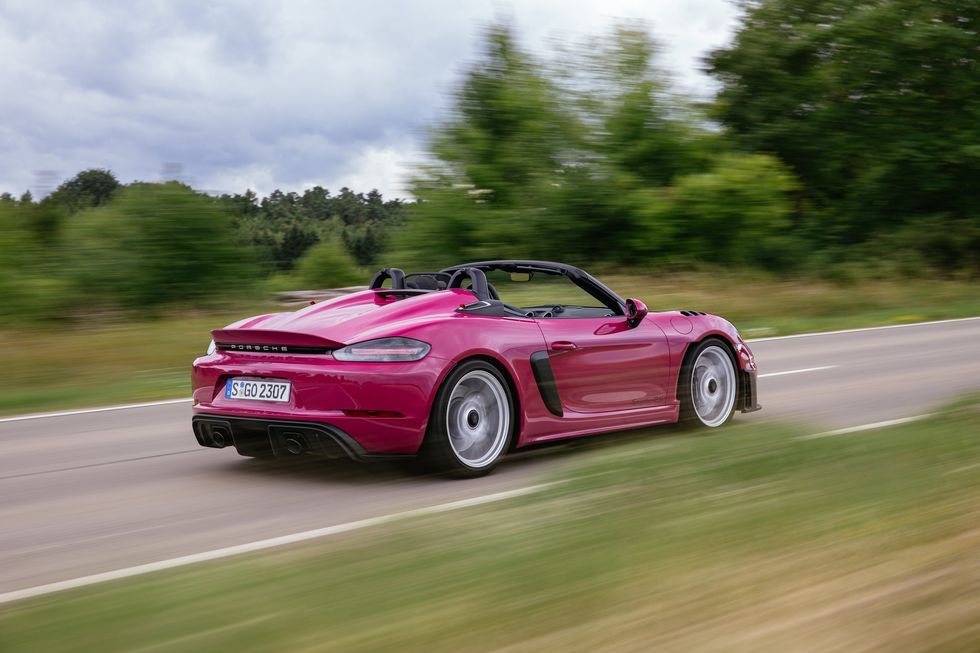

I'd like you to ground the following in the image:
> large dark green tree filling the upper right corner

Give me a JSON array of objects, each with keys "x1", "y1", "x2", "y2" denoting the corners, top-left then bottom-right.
[{"x1": 708, "y1": 0, "x2": 980, "y2": 247}]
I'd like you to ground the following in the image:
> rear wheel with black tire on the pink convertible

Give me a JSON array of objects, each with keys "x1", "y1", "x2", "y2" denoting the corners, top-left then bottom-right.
[{"x1": 419, "y1": 360, "x2": 516, "y2": 478}]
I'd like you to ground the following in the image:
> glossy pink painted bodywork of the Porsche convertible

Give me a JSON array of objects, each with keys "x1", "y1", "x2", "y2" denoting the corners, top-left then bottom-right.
[{"x1": 192, "y1": 260, "x2": 755, "y2": 455}]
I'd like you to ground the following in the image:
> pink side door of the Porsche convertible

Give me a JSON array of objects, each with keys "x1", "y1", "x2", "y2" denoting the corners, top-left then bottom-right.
[{"x1": 535, "y1": 316, "x2": 670, "y2": 413}]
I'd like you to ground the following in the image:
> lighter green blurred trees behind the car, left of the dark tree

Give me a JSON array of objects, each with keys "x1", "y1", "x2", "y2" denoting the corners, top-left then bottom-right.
[{"x1": 392, "y1": 25, "x2": 797, "y2": 269}]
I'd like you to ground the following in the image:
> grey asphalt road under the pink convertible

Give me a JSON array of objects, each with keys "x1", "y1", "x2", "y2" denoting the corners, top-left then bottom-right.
[{"x1": 0, "y1": 319, "x2": 980, "y2": 593}]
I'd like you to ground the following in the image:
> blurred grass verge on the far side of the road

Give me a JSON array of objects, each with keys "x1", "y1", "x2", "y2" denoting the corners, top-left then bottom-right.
[{"x1": 0, "y1": 273, "x2": 980, "y2": 414}]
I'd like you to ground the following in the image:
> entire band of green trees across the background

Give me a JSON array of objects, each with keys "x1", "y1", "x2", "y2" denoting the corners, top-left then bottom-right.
[{"x1": 0, "y1": 0, "x2": 980, "y2": 320}]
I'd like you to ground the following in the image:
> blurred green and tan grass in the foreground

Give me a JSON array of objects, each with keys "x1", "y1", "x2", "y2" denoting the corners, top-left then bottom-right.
[{"x1": 0, "y1": 397, "x2": 980, "y2": 652}]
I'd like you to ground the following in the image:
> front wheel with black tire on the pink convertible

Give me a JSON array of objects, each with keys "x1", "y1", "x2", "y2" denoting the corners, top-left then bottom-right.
[{"x1": 677, "y1": 338, "x2": 738, "y2": 428}]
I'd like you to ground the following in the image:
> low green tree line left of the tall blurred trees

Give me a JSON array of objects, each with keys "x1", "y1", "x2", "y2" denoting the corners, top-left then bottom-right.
[{"x1": 0, "y1": 169, "x2": 405, "y2": 324}]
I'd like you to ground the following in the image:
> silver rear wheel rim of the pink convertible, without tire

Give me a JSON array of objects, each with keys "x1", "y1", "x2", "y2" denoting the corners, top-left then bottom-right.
[{"x1": 446, "y1": 370, "x2": 510, "y2": 468}]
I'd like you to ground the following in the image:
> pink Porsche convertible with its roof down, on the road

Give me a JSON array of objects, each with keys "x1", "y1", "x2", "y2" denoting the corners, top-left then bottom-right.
[{"x1": 193, "y1": 260, "x2": 759, "y2": 476}]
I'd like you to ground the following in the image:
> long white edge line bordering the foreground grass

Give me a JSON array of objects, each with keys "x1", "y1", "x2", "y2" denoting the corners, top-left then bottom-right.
[{"x1": 0, "y1": 483, "x2": 557, "y2": 604}]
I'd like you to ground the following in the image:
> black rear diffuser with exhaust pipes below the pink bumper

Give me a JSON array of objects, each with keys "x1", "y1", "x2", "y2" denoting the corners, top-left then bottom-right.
[{"x1": 191, "y1": 414, "x2": 410, "y2": 460}]
